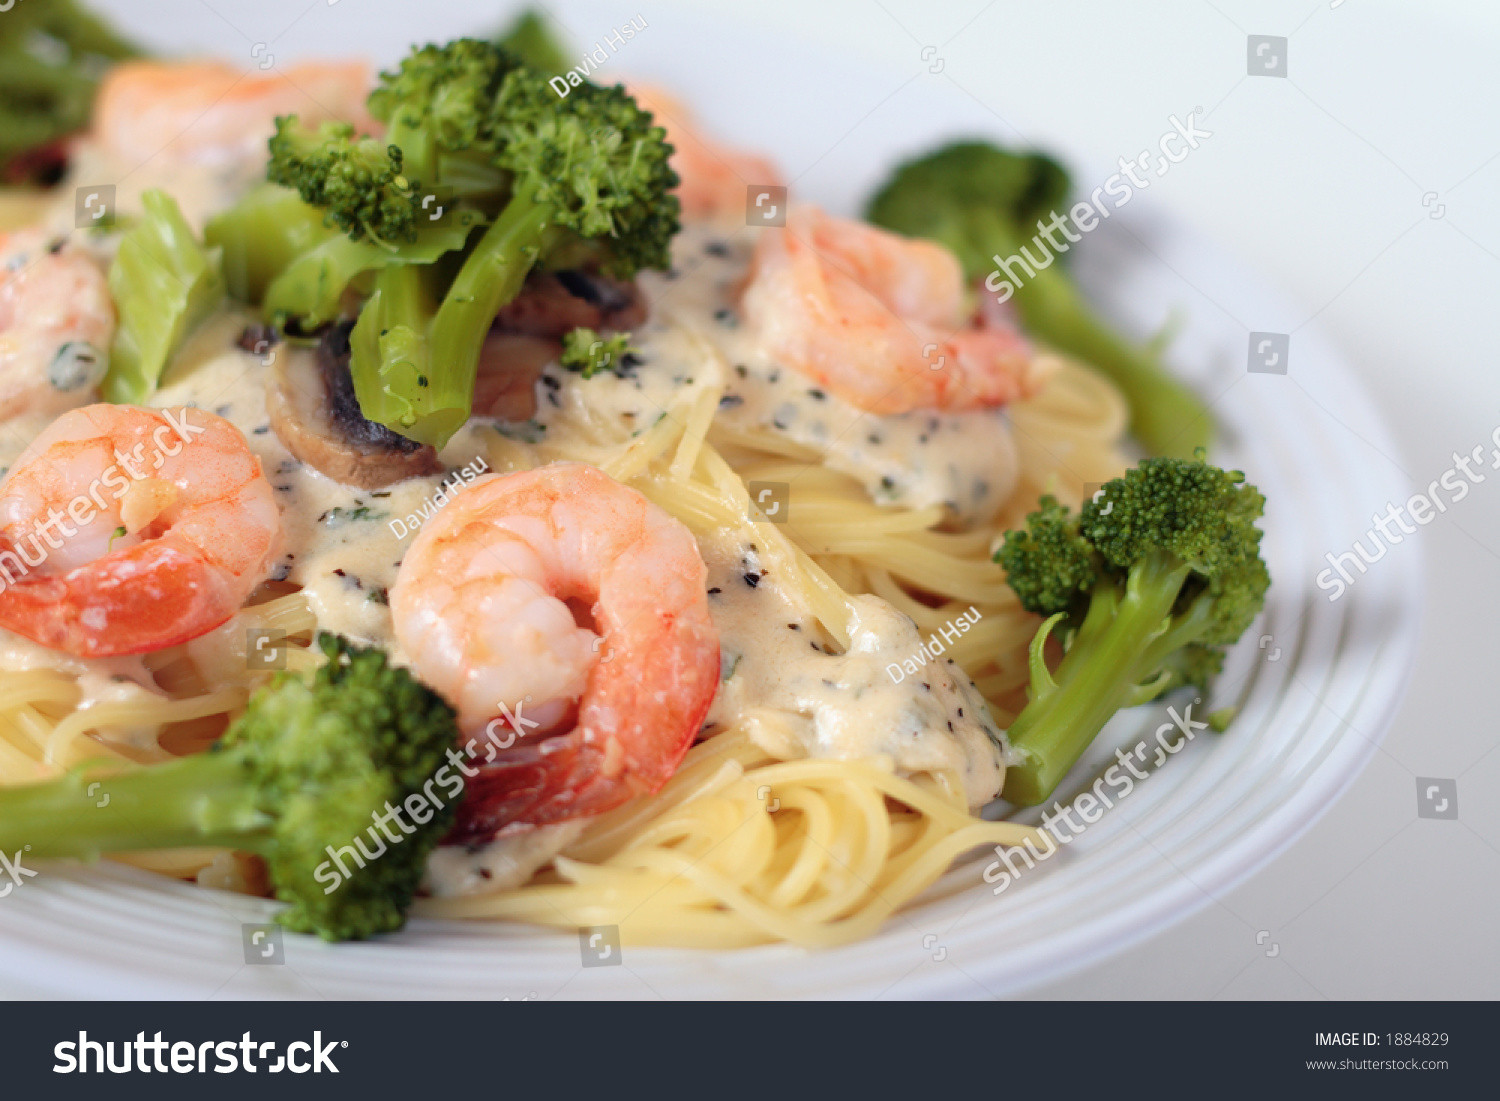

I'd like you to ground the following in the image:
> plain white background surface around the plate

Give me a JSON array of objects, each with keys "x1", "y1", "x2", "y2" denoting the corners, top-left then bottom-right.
[{"x1": 49, "y1": 0, "x2": 1500, "y2": 1002}]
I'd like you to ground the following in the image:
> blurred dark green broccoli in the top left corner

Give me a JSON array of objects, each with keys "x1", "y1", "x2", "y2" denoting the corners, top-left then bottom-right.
[{"x1": 0, "y1": 0, "x2": 140, "y2": 183}]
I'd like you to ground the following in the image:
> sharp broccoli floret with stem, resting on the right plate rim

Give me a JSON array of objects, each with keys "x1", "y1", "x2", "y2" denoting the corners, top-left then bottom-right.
[{"x1": 995, "y1": 458, "x2": 1271, "y2": 804}]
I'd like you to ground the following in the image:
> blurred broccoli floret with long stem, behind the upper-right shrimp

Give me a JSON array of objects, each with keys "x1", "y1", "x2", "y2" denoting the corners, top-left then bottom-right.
[{"x1": 867, "y1": 141, "x2": 1214, "y2": 458}]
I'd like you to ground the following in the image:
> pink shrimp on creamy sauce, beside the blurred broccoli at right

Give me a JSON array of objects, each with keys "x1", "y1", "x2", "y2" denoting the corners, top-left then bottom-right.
[{"x1": 744, "y1": 207, "x2": 1046, "y2": 414}]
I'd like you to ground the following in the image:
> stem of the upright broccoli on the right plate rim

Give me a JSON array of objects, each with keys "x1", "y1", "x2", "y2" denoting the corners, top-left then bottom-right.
[{"x1": 1005, "y1": 552, "x2": 1193, "y2": 806}]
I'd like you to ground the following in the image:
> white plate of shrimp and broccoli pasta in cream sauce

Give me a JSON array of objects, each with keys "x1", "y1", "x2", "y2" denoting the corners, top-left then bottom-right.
[{"x1": 0, "y1": 3, "x2": 1418, "y2": 998}]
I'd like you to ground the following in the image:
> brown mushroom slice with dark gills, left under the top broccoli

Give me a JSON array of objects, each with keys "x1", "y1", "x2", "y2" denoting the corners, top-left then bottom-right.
[{"x1": 266, "y1": 324, "x2": 443, "y2": 489}]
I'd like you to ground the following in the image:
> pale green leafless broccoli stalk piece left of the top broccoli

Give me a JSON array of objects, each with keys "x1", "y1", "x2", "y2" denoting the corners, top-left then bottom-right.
[{"x1": 102, "y1": 191, "x2": 224, "y2": 404}]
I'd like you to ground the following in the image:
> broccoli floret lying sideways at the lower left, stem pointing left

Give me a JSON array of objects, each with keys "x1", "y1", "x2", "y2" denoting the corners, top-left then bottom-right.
[{"x1": 0, "y1": 635, "x2": 458, "y2": 941}]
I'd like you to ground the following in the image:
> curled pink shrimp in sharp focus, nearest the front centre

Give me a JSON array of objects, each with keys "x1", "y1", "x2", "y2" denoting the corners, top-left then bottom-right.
[{"x1": 390, "y1": 462, "x2": 719, "y2": 840}]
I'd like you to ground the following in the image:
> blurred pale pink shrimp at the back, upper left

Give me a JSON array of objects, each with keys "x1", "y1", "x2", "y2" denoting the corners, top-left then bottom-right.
[{"x1": 93, "y1": 60, "x2": 371, "y2": 162}]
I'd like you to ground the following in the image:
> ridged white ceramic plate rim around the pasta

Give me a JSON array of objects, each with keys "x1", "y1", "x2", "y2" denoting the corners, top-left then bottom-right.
[{"x1": 0, "y1": 3, "x2": 1421, "y2": 999}]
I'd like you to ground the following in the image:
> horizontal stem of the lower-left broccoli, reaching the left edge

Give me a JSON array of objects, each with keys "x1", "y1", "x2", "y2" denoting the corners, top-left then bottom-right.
[{"x1": 0, "y1": 752, "x2": 272, "y2": 860}]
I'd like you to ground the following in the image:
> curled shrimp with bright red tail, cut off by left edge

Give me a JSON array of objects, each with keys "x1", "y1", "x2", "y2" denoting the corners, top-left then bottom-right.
[{"x1": 0, "y1": 405, "x2": 281, "y2": 657}]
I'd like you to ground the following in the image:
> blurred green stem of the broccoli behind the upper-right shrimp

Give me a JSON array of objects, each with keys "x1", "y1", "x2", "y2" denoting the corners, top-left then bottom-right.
[{"x1": 1016, "y1": 269, "x2": 1214, "y2": 459}]
